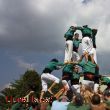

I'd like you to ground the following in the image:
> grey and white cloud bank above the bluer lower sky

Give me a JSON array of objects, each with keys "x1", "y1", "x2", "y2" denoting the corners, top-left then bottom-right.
[{"x1": 0, "y1": 0, "x2": 110, "y2": 53}]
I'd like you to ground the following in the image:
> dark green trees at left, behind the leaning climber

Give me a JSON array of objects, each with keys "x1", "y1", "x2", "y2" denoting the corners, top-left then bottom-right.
[{"x1": 0, "y1": 70, "x2": 41, "y2": 110}]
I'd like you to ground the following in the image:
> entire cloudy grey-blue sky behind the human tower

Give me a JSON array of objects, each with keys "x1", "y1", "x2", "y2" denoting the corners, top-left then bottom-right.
[{"x1": 0, "y1": 0, "x2": 110, "y2": 88}]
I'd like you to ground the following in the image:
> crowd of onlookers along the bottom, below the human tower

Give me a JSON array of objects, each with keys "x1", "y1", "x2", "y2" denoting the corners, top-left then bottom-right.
[{"x1": 8, "y1": 84, "x2": 110, "y2": 110}]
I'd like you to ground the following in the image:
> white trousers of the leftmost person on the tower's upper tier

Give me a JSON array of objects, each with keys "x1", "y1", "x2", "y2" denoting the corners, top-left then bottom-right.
[{"x1": 64, "y1": 40, "x2": 73, "y2": 62}]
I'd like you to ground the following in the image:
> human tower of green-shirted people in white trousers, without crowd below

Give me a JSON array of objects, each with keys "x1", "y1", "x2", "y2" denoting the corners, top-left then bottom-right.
[{"x1": 22, "y1": 25, "x2": 110, "y2": 110}]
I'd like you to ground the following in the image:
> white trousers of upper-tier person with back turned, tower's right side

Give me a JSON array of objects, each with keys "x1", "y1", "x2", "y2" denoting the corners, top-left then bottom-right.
[{"x1": 82, "y1": 37, "x2": 93, "y2": 53}]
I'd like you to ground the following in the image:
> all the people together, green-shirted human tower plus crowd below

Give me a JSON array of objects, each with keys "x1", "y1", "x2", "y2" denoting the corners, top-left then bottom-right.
[{"x1": 9, "y1": 25, "x2": 110, "y2": 110}]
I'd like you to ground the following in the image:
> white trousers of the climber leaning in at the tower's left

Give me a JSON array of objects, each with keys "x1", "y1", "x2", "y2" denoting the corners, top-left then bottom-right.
[{"x1": 41, "y1": 73, "x2": 60, "y2": 92}]
